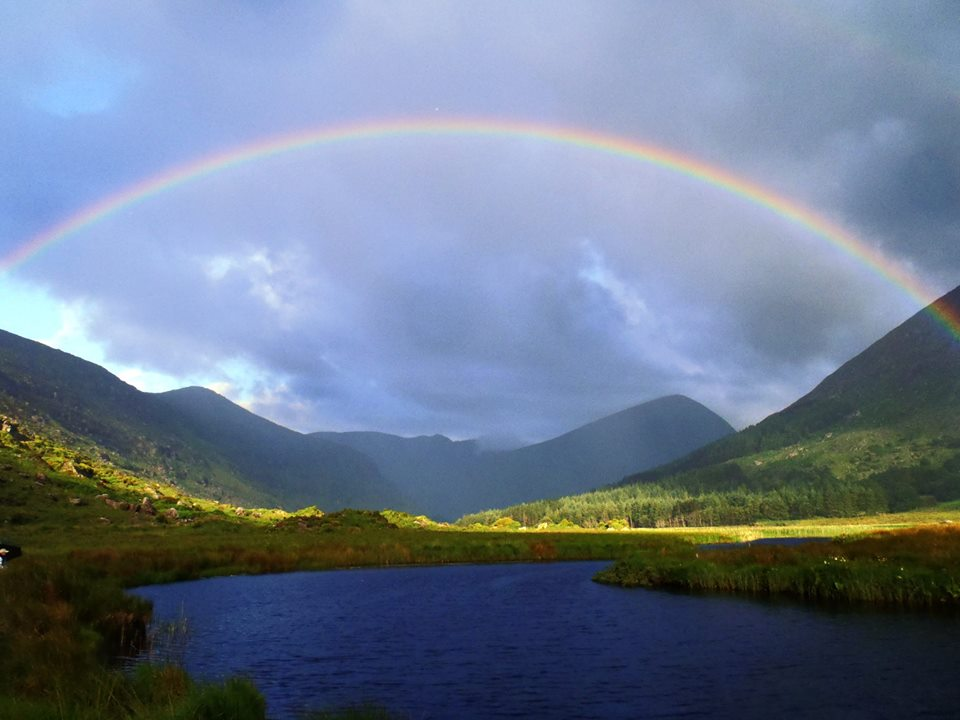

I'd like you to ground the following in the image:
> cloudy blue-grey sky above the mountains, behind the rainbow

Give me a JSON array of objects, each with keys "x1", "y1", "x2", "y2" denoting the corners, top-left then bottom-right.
[{"x1": 0, "y1": 0, "x2": 960, "y2": 445}]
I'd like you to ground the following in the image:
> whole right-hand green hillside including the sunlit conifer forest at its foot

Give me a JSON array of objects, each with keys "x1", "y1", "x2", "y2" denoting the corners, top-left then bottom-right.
[{"x1": 463, "y1": 288, "x2": 960, "y2": 526}]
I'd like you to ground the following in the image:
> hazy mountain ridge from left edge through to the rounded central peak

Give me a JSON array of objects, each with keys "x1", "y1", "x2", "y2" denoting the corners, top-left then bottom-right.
[{"x1": 0, "y1": 331, "x2": 732, "y2": 520}]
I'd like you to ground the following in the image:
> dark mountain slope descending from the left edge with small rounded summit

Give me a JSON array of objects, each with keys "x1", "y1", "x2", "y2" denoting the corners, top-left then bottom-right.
[{"x1": 0, "y1": 331, "x2": 400, "y2": 510}]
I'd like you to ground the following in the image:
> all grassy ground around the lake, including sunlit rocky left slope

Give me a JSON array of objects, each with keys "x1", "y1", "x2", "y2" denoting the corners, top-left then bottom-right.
[{"x1": 0, "y1": 430, "x2": 960, "y2": 720}]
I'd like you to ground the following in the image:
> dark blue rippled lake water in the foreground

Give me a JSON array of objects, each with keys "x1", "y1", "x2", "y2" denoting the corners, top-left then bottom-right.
[{"x1": 137, "y1": 563, "x2": 960, "y2": 720}]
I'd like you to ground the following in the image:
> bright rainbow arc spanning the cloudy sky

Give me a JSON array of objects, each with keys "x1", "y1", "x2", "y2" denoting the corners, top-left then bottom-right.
[{"x1": 0, "y1": 117, "x2": 960, "y2": 338}]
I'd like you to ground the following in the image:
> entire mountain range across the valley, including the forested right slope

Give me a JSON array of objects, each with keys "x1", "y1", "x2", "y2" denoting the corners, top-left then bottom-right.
[{"x1": 7, "y1": 288, "x2": 960, "y2": 525}]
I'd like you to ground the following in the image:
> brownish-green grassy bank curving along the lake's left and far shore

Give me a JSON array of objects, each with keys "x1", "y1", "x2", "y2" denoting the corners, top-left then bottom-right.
[{"x1": 0, "y1": 506, "x2": 683, "y2": 720}]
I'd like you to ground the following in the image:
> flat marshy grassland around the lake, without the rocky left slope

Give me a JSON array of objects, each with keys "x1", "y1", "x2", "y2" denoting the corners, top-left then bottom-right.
[{"x1": 7, "y1": 524, "x2": 960, "y2": 720}]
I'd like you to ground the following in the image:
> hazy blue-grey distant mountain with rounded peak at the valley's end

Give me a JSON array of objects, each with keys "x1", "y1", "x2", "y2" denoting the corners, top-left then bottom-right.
[{"x1": 316, "y1": 395, "x2": 733, "y2": 519}]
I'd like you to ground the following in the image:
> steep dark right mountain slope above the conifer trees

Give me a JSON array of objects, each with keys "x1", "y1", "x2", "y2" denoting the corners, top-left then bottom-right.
[{"x1": 624, "y1": 287, "x2": 960, "y2": 483}]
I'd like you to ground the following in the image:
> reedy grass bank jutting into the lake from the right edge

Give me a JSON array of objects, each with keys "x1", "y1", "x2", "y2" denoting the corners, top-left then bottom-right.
[{"x1": 596, "y1": 525, "x2": 960, "y2": 610}]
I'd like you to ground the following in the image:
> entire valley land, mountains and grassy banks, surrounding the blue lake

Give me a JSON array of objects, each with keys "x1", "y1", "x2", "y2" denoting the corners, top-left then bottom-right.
[{"x1": 0, "y1": 284, "x2": 960, "y2": 718}]
